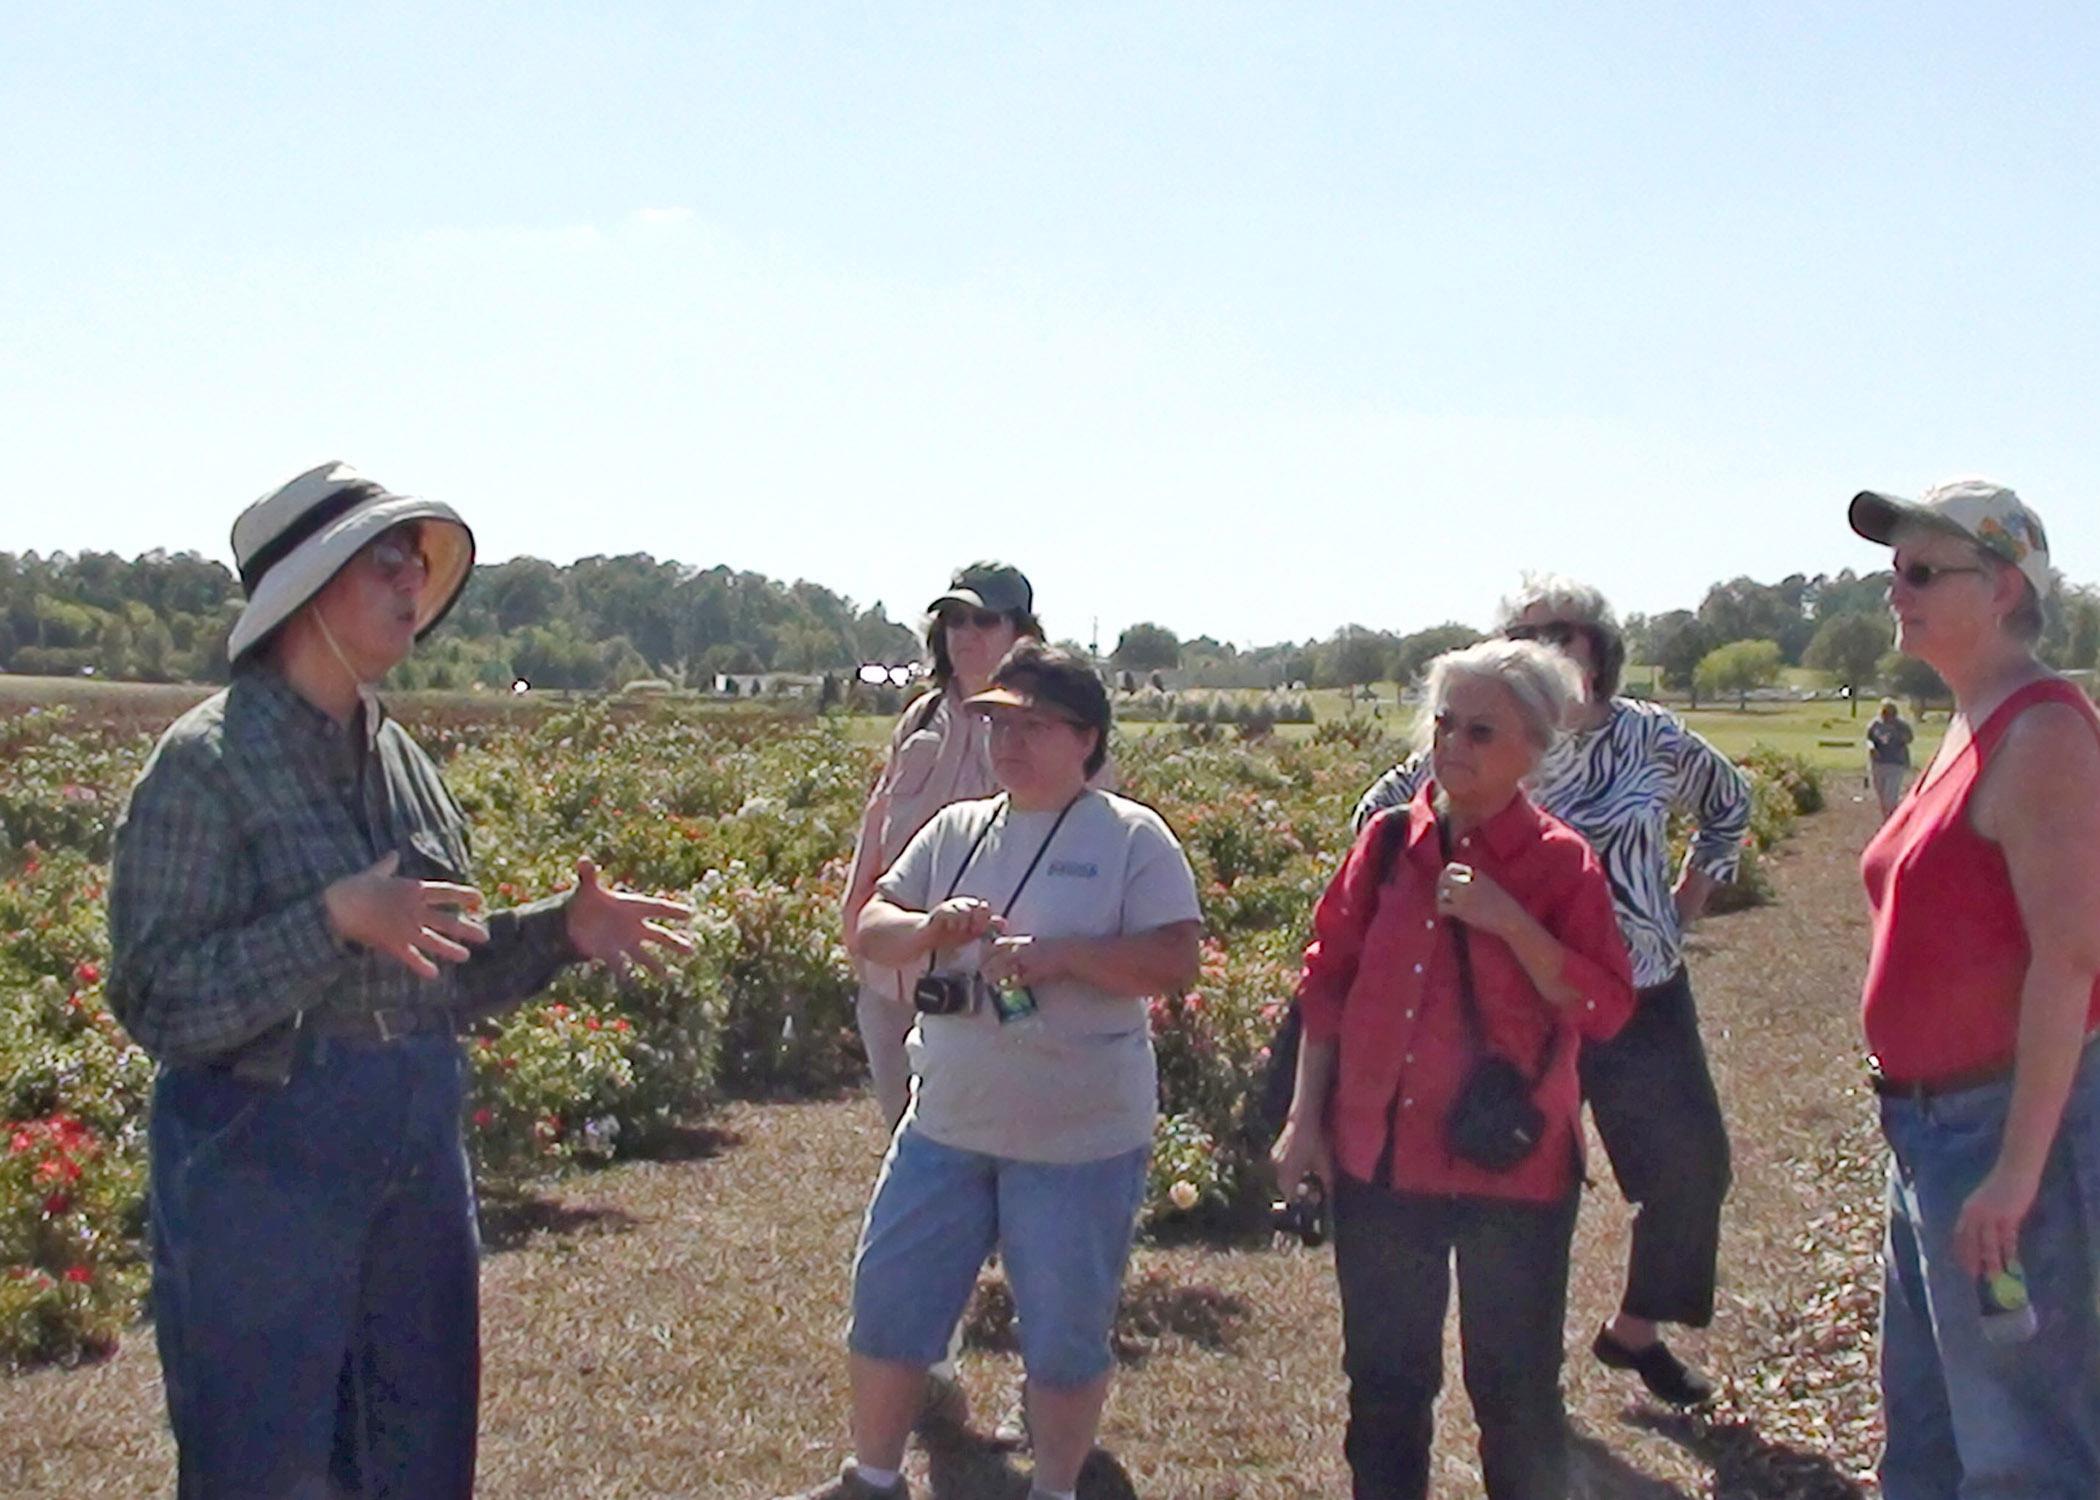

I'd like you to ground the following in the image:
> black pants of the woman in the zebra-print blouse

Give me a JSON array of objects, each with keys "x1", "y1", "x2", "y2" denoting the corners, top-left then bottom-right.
[{"x1": 1581, "y1": 968, "x2": 1730, "y2": 1328}]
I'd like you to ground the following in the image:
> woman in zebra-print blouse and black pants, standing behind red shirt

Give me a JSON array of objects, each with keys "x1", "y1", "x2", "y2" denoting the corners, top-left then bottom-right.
[{"x1": 1357, "y1": 576, "x2": 1749, "y2": 1405}]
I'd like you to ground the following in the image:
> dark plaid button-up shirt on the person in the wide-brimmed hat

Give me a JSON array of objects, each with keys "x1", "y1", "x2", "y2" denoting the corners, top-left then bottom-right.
[{"x1": 107, "y1": 668, "x2": 573, "y2": 1078}]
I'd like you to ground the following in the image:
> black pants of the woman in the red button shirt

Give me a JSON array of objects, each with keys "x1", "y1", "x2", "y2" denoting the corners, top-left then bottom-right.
[{"x1": 1334, "y1": 1176, "x2": 1577, "y2": 1500}]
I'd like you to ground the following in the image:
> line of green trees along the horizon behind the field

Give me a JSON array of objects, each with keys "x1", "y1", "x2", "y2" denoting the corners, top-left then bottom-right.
[{"x1": 0, "y1": 550, "x2": 2100, "y2": 702}]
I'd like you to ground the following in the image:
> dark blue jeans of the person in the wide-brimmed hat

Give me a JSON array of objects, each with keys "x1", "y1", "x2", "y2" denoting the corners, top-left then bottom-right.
[{"x1": 149, "y1": 1036, "x2": 481, "y2": 1500}]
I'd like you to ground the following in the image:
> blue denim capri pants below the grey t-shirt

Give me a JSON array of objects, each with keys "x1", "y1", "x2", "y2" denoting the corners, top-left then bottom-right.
[{"x1": 846, "y1": 1124, "x2": 1151, "y2": 1391}]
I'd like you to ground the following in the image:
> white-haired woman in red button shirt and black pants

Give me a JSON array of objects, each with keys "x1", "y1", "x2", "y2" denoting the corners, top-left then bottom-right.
[{"x1": 1275, "y1": 641, "x2": 1634, "y2": 1500}]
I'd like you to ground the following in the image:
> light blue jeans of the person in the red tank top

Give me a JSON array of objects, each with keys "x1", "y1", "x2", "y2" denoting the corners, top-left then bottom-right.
[{"x1": 1882, "y1": 1048, "x2": 2100, "y2": 1500}]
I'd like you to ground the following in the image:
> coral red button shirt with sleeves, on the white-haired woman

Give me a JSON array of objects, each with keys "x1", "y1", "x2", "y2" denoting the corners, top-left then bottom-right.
[{"x1": 1298, "y1": 784, "x2": 1634, "y2": 1202}]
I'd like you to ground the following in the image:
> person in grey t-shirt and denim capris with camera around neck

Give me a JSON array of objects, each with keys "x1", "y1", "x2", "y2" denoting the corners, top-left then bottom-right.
[{"x1": 804, "y1": 641, "x2": 1201, "y2": 1500}]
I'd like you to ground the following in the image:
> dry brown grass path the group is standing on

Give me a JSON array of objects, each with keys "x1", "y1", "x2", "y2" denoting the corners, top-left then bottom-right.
[{"x1": 0, "y1": 784, "x2": 1880, "y2": 1500}]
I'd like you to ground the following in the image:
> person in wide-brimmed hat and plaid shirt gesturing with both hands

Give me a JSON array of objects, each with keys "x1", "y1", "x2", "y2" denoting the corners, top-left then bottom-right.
[{"x1": 109, "y1": 464, "x2": 691, "y2": 1500}]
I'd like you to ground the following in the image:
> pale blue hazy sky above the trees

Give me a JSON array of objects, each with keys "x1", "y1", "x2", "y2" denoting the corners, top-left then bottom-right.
[{"x1": 0, "y1": 0, "x2": 2100, "y2": 643}]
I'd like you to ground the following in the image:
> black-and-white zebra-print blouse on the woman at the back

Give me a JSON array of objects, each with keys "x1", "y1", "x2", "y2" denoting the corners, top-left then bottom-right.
[{"x1": 1357, "y1": 697, "x2": 1749, "y2": 989}]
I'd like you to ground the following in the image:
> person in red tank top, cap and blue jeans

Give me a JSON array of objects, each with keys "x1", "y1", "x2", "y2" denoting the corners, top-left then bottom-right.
[{"x1": 1850, "y1": 479, "x2": 2100, "y2": 1500}]
